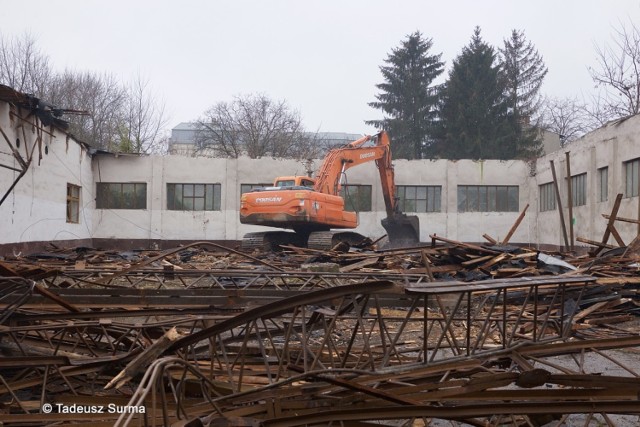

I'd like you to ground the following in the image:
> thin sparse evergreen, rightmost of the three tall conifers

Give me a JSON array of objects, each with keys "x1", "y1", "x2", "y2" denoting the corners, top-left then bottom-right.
[{"x1": 500, "y1": 30, "x2": 548, "y2": 157}]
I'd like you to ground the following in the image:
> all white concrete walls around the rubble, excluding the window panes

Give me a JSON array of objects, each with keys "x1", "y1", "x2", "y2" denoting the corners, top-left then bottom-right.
[{"x1": 0, "y1": 91, "x2": 640, "y2": 251}]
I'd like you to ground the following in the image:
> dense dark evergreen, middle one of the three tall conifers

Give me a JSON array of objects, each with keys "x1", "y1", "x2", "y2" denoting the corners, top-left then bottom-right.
[{"x1": 438, "y1": 27, "x2": 516, "y2": 159}]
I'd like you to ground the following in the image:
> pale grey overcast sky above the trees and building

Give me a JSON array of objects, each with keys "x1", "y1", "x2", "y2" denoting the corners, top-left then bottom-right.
[{"x1": 0, "y1": 0, "x2": 640, "y2": 134}]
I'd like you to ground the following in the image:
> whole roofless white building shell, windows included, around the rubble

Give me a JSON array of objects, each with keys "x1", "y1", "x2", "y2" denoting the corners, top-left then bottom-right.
[{"x1": 0, "y1": 89, "x2": 640, "y2": 253}]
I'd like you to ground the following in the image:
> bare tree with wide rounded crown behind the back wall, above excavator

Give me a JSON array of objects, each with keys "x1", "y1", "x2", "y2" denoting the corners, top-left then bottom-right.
[{"x1": 195, "y1": 94, "x2": 316, "y2": 159}]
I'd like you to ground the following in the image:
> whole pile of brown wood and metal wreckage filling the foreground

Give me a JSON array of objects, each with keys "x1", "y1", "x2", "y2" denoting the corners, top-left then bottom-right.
[{"x1": 0, "y1": 203, "x2": 640, "y2": 426}]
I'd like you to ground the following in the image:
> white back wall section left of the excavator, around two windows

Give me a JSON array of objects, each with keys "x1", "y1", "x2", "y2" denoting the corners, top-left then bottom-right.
[{"x1": 93, "y1": 155, "x2": 316, "y2": 244}]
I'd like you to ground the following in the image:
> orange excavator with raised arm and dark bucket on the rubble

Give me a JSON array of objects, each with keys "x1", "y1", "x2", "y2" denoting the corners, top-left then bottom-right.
[{"x1": 240, "y1": 131, "x2": 420, "y2": 250}]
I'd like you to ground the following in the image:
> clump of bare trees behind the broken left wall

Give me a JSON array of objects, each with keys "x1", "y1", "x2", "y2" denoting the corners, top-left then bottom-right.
[{"x1": 0, "y1": 34, "x2": 167, "y2": 153}]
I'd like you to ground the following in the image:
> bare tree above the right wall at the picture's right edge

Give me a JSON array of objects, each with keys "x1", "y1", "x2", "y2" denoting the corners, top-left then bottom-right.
[{"x1": 589, "y1": 22, "x2": 640, "y2": 120}]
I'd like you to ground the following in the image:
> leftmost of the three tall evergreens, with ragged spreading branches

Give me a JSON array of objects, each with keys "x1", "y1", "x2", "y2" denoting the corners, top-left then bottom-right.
[{"x1": 366, "y1": 31, "x2": 444, "y2": 159}]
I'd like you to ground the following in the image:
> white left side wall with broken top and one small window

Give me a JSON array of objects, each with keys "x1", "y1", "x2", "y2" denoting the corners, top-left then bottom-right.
[{"x1": 0, "y1": 102, "x2": 94, "y2": 244}]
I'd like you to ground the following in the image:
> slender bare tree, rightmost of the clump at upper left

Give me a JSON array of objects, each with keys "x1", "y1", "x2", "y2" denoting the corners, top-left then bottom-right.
[{"x1": 118, "y1": 75, "x2": 167, "y2": 153}]
